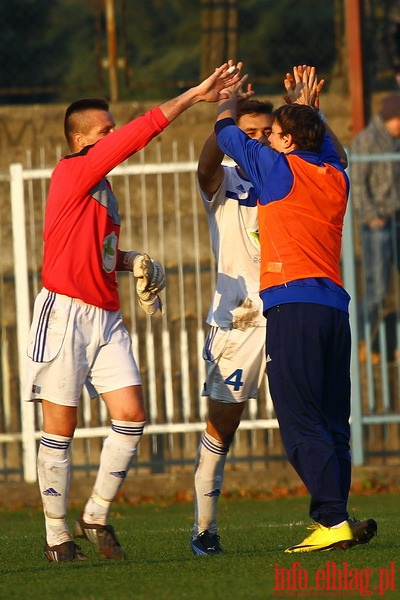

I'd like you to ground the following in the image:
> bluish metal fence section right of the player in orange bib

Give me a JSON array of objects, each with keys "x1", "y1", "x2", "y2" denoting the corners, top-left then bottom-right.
[{"x1": 343, "y1": 153, "x2": 400, "y2": 464}]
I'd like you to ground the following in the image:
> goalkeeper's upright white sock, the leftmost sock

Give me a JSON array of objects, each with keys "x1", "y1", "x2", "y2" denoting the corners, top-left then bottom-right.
[{"x1": 37, "y1": 432, "x2": 72, "y2": 546}]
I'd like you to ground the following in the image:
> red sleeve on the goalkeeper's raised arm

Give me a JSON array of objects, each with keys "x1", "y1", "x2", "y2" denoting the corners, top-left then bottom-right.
[{"x1": 88, "y1": 107, "x2": 169, "y2": 177}]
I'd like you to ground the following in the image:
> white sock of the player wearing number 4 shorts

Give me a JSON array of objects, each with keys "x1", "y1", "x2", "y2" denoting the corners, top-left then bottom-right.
[{"x1": 193, "y1": 432, "x2": 229, "y2": 536}]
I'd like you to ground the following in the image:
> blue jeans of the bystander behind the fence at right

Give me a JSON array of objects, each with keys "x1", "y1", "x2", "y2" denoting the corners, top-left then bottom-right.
[{"x1": 358, "y1": 213, "x2": 400, "y2": 339}]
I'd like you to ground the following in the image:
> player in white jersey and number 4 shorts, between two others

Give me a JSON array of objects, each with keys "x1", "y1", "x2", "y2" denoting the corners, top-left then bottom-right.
[{"x1": 191, "y1": 94, "x2": 273, "y2": 555}]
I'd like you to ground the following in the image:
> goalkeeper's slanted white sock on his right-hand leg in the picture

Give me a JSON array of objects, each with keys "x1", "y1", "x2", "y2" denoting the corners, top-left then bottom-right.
[{"x1": 82, "y1": 419, "x2": 145, "y2": 525}]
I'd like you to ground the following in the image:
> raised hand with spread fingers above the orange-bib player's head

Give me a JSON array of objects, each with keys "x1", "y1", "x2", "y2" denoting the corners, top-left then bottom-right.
[{"x1": 283, "y1": 65, "x2": 325, "y2": 108}]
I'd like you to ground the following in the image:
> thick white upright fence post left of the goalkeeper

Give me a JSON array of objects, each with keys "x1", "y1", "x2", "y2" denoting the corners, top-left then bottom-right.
[{"x1": 10, "y1": 164, "x2": 36, "y2": 482}]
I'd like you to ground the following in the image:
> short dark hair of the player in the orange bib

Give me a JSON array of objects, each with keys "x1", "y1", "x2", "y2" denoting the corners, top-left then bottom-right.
[{"x1": 272, "y1": 104, "x2": 326, "y2": 152}]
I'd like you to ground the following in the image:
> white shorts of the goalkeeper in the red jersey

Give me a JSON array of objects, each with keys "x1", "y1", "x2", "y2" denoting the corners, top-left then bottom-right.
[{"x1": 25, "y1": 288, "x2": 141, "y2": 406}]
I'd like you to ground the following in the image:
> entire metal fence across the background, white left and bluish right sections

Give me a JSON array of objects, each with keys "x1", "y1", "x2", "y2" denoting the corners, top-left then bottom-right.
[{"x1": 0, "y1": 142, "x2": 400, "y2": 481}]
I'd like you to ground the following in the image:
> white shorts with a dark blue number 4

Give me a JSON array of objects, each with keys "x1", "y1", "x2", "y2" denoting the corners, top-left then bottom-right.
[{"x1": 201, "y1": 327, "x2": 266, "y2": 403}]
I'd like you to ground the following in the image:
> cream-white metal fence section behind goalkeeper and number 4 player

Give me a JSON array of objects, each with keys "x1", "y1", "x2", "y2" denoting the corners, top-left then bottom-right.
[{"x1": 0, "y1": 143, "x2": 283, "y2": 481}]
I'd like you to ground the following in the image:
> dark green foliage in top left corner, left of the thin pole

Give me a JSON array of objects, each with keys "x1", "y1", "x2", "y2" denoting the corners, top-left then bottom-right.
[{"x1": 0, "y1": 0, "x2": 96, "y2": 103}]
